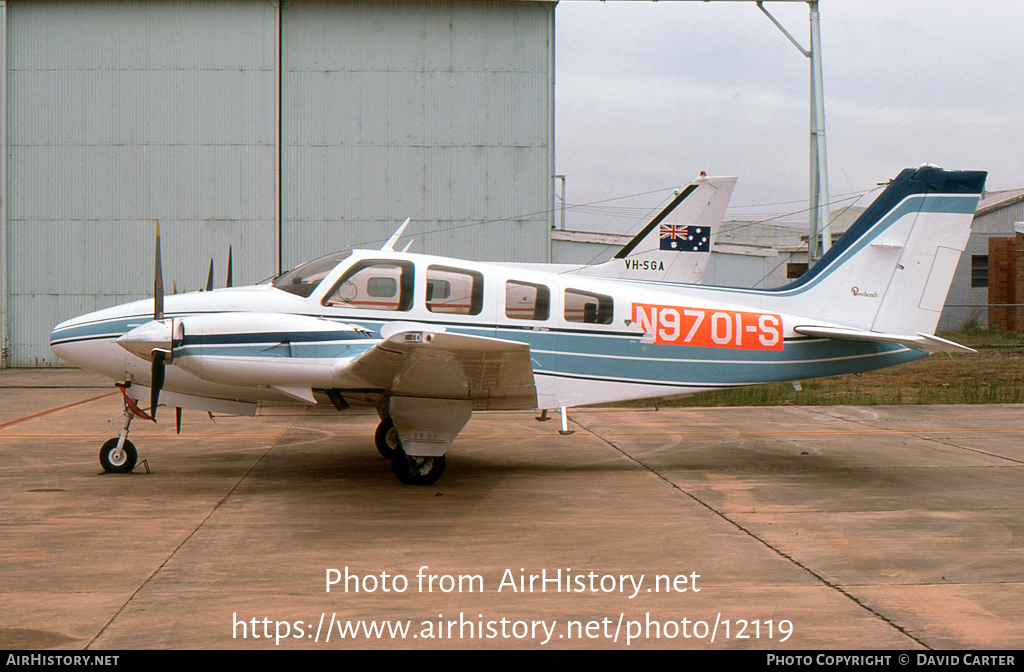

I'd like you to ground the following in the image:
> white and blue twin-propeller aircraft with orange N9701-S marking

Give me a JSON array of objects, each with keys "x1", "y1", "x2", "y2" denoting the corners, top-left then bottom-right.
[{"x1": 51, "y1": 166, "x2": 986, "y2": 485}]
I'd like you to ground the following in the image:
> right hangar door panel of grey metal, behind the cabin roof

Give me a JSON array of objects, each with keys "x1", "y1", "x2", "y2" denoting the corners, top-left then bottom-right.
[{"x1": 282, "y1": 1, "x2": 554, "y2": 267}]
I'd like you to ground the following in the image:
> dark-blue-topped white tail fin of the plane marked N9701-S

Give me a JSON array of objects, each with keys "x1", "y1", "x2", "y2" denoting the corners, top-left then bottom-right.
[{"x1": 773, "y1": 166, "x2": 987, "y2": 334}]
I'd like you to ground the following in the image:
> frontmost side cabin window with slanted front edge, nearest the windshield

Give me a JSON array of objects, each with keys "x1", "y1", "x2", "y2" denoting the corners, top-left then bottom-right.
[{"x1": 324, "y1": 259, "x2": 413, "y2": 310}]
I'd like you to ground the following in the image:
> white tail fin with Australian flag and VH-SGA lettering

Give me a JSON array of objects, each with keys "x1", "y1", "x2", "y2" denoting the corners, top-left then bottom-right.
[{"x1": 578, "y1": 176, "x2": 736, "y2": 283}]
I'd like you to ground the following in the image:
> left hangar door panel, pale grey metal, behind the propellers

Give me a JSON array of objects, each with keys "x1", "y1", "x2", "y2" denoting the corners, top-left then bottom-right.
[{"x1": 2, "y1": 0, "x2": 278, "y2": 367}]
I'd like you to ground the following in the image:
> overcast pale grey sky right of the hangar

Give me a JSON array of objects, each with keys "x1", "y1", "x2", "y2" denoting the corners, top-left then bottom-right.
[{"x1": 555, "y1": 0, "x2": 1024, "y2": 230}]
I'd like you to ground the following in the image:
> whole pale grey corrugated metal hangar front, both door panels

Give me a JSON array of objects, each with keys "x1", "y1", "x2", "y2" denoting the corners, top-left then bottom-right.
[{"x1": 0, "y1": 0, "x2": 556, "y2": 367}]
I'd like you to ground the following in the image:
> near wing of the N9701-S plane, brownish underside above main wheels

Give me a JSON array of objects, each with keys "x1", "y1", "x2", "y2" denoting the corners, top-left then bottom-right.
[{"x1": 342, "y1": 331, "x2": 537, "y2": 411}]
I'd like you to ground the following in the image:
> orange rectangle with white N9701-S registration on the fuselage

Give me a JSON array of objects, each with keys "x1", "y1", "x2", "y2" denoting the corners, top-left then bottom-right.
[{"x1": 633, "y1": 303, "x2": 782, "y2": 350}]
